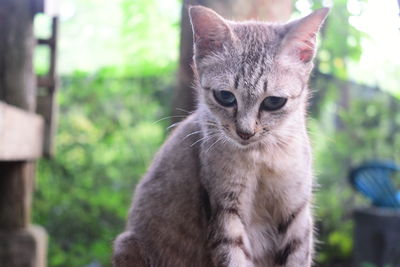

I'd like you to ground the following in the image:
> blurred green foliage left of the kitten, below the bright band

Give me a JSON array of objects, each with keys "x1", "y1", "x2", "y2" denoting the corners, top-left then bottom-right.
[{"x1": 34, "y1": 71, "x2": 170, "y2": 266}]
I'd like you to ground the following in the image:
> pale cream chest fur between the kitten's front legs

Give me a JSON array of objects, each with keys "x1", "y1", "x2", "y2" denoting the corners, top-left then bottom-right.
[{"x1": 238, "y1": 151, "x2": 310, "y2": 260}]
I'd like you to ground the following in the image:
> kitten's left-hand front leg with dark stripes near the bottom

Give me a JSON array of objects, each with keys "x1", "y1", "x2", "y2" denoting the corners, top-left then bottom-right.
[{"x1": 201, "y1": 149, "x2": 256, "y2": 267}]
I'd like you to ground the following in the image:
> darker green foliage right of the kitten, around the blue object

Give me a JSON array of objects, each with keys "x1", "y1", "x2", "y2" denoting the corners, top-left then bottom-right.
[{"x1": 309, "y1": 81, "x2": 400, "y2": 263}]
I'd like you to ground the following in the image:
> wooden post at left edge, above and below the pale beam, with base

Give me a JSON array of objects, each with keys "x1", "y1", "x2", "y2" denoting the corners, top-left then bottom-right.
[{"x1": 0, "y1": 0, "x2": 46, "y2": 267}]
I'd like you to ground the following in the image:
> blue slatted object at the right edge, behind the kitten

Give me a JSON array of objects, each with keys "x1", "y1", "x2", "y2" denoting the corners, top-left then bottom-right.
[{"x1": 349, "y1": 161, "x2": 400, "y2": 208}]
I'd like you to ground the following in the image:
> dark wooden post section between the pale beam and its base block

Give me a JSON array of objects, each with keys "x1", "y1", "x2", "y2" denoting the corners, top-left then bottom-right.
[{"x1": 0, "y1": 161, "x2": 35, "y2": 231}]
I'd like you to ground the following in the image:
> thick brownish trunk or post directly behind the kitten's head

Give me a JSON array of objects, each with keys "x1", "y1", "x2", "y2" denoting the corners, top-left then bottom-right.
[{"x1": 172, "y1": 0, "x2": 292, "y2": 122}]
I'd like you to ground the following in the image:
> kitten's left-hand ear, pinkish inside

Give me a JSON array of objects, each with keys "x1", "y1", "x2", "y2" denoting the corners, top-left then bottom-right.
[{"x1": 189, "y1": 6, "x2": 232, "y2": 58}]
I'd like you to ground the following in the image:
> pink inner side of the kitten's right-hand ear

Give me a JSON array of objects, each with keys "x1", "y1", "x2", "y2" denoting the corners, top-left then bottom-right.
[{"x1": 281, "y1": 8, "x2": 329, "y2": 63}]
